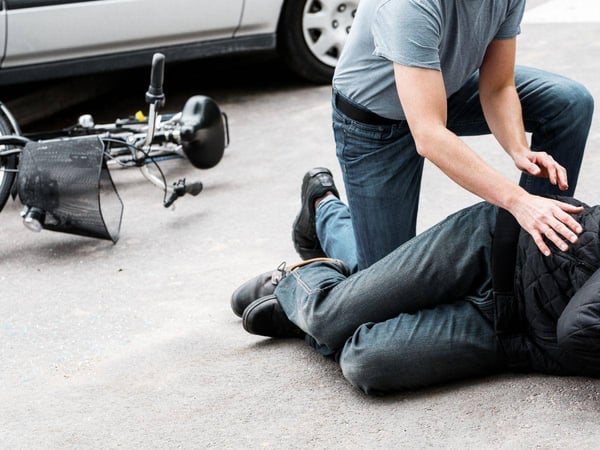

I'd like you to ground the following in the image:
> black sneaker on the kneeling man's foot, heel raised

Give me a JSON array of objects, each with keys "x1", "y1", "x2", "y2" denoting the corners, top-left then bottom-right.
[{"x1": 292, "y1": 167, "x2": 340, "y2": 259}]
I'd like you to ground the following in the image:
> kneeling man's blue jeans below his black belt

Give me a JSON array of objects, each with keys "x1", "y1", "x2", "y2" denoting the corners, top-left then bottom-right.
[{"x1": 333, "y1": 67, "x2": 594, "y2": 269}]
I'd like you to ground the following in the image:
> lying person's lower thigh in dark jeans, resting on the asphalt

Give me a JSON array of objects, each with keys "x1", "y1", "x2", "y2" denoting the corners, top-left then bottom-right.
[{"x1": 337, "y1": 301, "x2": 505, "y2": 394}]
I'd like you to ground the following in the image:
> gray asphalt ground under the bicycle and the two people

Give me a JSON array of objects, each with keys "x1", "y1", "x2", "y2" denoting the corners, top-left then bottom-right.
[{"x1": 0, "y1": 0, "x2": 600, "y2": 449}]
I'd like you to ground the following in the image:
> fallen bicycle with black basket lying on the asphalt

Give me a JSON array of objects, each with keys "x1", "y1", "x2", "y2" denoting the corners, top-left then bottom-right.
[{"x1": 0, "y1": 53, "x2": 229, "y2": 243}]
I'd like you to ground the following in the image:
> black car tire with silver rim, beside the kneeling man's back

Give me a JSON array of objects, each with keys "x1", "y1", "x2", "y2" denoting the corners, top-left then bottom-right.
[{"x1": 277, "y1": 0, "x2": 358, "y2": 84}]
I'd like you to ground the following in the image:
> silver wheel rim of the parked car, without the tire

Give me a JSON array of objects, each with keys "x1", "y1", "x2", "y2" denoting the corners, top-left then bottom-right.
[{"x1": 302, "y1": 0, "x2": 358, "y2": 67}]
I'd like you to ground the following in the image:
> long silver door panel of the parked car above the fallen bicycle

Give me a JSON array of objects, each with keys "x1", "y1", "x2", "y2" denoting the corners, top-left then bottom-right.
[{"x1": 2, "y1": 0, "x2": 244, "y2": 68}]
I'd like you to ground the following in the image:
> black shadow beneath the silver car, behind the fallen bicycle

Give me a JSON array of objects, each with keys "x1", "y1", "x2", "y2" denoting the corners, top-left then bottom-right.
[{"x1": 8, "y1": 53, "x2": 314, "y2": 133}]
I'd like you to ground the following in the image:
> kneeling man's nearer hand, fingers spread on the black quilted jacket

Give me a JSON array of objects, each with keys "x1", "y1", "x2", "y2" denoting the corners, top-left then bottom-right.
[{"x1": 510, "y1": 193, "x2": 583, "y2": 256}]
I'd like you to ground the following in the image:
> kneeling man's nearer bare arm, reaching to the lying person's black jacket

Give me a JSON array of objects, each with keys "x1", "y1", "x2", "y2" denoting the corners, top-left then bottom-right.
[{"x1": 394, "y1": 64, "x2": 581, "y2": 255}]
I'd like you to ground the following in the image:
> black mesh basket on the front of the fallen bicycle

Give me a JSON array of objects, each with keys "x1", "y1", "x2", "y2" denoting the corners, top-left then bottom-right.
[{"x1": 18, "y1": 136, "x2": 123, "y2": 242}]
